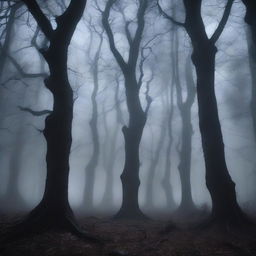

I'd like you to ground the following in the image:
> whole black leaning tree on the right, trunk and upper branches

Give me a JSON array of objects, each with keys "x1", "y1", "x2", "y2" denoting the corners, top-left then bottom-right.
[{"x1": 158, "y1": 0, "x2": 251, "y2": 227}]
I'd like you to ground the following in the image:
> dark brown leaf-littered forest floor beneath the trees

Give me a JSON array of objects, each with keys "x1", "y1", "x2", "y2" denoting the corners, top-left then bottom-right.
[{"x1": 0, "y1": 214, "x2": 256, "y2": 256}]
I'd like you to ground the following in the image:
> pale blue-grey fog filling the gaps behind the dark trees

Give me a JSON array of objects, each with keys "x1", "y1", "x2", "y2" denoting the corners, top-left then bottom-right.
[{"x1": 0, "y1": 0, "x2": 256, "y2": 219}]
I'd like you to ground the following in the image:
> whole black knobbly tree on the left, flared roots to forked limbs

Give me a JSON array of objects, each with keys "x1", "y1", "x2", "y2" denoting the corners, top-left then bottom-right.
[{"x1": 0, "y1": 0, "x2": 100, "y2": 240}]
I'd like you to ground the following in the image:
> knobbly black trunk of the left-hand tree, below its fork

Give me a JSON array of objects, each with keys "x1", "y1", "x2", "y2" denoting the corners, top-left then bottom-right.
[{"x1": 28, "y1": 44, "x2": 73, "y2": 225}]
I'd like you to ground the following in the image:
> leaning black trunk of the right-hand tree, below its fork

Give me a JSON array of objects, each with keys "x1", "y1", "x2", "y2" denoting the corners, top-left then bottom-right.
[{"x1": 192, "y1": 44, "x2": 243, "y2": 224}]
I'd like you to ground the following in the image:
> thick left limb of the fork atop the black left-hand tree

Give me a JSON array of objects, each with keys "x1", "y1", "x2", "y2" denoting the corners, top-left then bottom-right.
[{"x1": 22, "y1": 0, "x2": 53, "y2": 39}]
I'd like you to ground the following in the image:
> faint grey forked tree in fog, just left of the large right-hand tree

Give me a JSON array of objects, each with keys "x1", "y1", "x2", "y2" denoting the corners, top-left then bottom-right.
[{"x1": 172, "y1": 32, "x2": 196, "y2": 216}]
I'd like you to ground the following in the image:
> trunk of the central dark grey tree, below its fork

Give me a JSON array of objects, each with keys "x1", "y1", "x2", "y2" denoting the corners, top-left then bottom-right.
[{"x1": 115, "y1": 75, "x2": 146, "y2": 219}]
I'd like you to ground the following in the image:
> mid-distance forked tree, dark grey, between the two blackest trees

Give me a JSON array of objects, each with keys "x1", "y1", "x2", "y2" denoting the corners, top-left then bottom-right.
[{"x1": 102, "y1": 0, "x2": 151, "y2": 219}]
